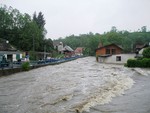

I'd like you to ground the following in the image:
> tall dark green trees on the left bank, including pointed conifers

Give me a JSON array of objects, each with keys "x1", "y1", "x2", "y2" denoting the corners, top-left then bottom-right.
[{"x1": 0, "y1": 6, "x2": 53, "y2": 51}]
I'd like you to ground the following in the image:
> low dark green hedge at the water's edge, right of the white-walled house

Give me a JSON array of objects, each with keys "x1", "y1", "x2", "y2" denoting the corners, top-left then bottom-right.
[{"x1": 127, "y1": 58, "x2": 150, "y2": 67}]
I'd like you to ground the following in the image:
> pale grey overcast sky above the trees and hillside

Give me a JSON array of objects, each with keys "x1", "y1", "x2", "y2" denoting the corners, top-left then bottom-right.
[{"x1": 0, "y1": 0, "x2": 150, "y2": 39}]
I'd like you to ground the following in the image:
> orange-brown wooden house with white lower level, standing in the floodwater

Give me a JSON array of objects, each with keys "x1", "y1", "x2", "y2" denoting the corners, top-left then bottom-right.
[{"x1": 96, "y1": 44, "x2": 135, "y2": 64}]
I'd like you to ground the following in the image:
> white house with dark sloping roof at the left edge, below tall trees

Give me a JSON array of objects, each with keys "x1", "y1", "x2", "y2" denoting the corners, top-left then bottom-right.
[{"x1": 0, "y1": 39, "x2": 22, "y2": 62}]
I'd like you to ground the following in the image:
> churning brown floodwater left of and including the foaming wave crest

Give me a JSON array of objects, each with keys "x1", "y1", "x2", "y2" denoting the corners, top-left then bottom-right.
[{"x1": 0, "y1": 57, "x2": 134, "y2": 113}]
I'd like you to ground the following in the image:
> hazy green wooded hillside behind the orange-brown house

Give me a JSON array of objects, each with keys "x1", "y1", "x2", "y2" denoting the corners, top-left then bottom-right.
[{"x1": 58, "y1": 26, "x2": 150, "y2": 55}]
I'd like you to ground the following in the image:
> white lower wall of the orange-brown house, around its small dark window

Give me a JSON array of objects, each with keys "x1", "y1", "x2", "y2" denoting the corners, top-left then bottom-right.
[{"x1": 98, "y1": 54, "x2": 135, "y2": 64}]
